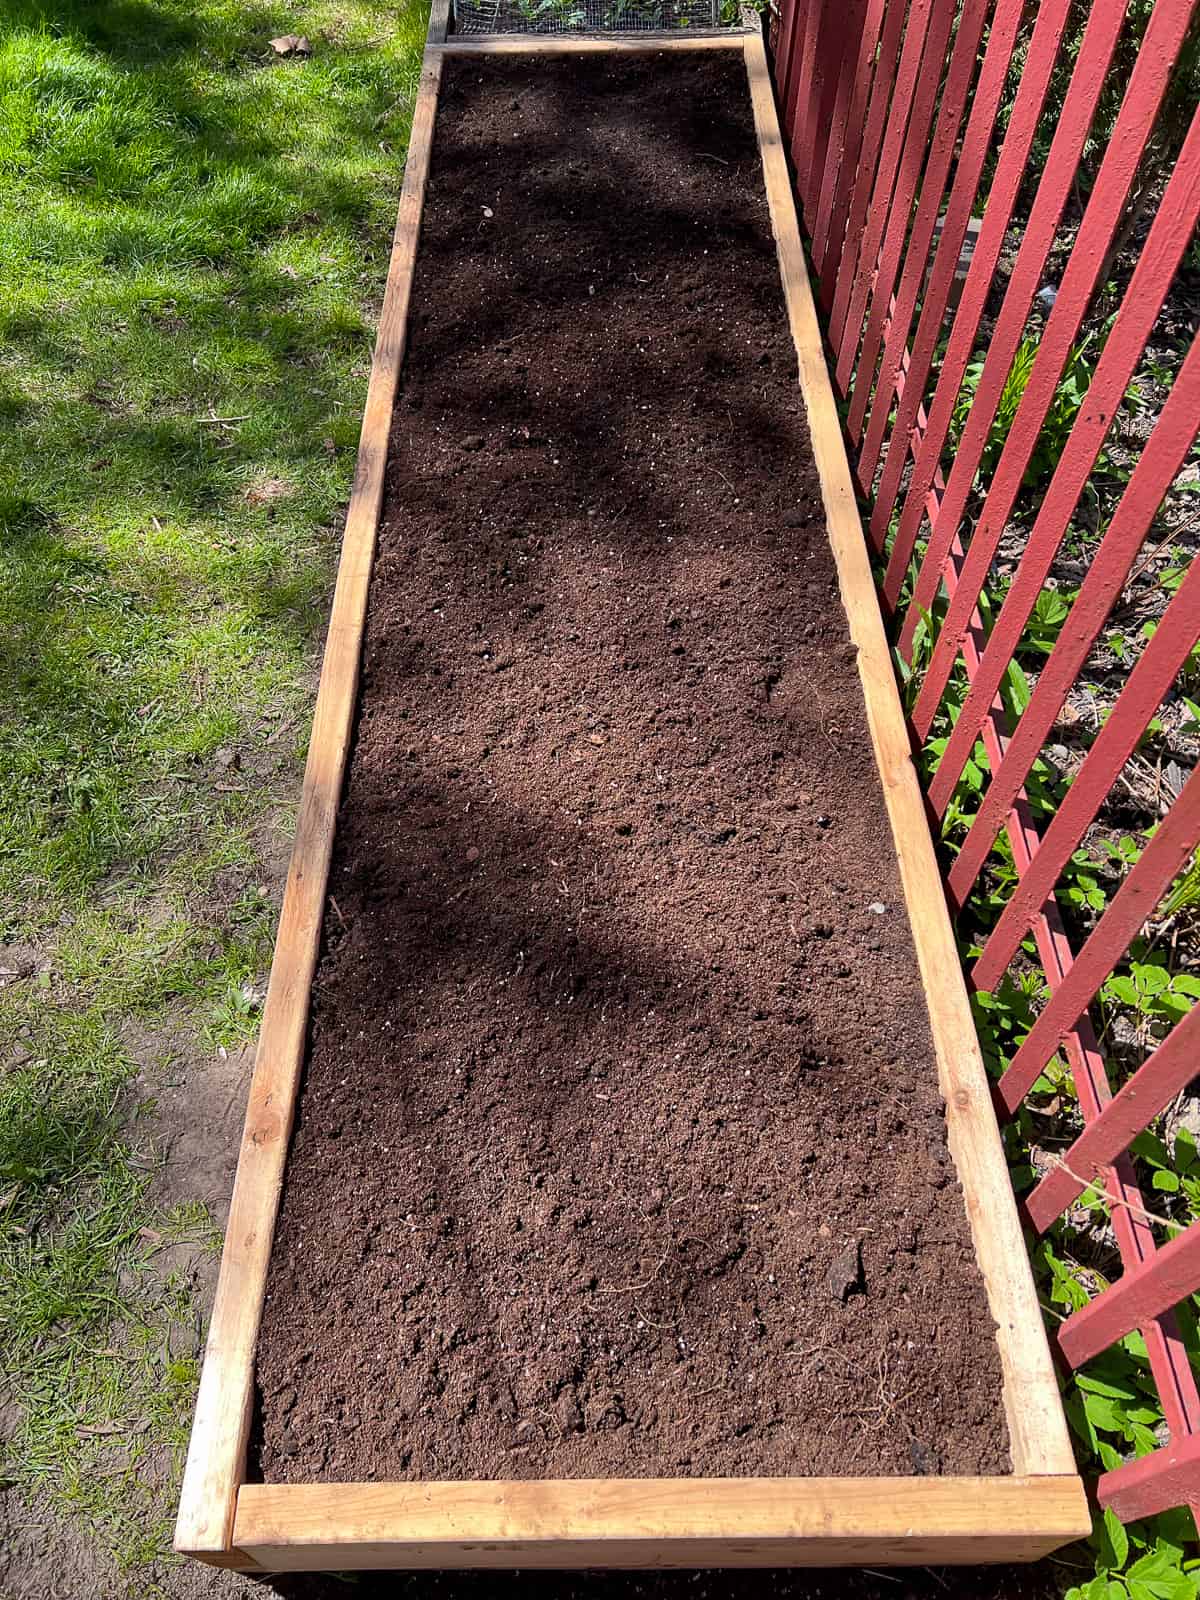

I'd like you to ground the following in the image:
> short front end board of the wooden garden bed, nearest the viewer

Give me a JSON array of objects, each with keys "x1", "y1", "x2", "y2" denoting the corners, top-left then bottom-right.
[{"x1": 234, "y1": 1477, "x2": 1090, "y2": 1571}]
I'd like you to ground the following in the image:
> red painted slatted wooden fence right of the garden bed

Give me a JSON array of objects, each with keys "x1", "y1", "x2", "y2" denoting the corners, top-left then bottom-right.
[{"x1": 773, "y1": 0, "x2": 1200, "y2": 1522}]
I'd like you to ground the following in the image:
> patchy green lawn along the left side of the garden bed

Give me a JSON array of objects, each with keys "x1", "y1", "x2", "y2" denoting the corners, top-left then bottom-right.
[{"x1": 0, "y1": 0, "x2": 424, "y2": 1587}]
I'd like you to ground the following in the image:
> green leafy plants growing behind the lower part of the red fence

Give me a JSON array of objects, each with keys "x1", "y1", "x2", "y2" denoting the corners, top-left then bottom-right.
[{"x1": 896, "y1": 521, "x2": 1200, "y2": 1600}]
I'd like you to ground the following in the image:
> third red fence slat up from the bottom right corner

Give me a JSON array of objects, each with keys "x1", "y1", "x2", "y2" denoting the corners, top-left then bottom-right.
[{"x1": 1027, "y1": 1006, "x2": 1200, "y2": 1232}]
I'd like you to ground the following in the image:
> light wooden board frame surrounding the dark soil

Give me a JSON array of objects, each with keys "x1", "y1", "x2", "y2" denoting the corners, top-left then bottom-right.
[{"x1": 174, "y1": 12, "x2": 1091, "y2": 1571}]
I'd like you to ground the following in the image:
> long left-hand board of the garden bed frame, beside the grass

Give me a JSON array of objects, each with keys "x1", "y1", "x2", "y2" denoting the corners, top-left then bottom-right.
[{"x1": 174, "y1": 0, "x2": 448, "y2": 1555}]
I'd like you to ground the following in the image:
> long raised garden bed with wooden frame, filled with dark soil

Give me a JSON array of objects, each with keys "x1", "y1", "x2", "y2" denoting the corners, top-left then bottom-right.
[{"x1": 178, "y1": 6, "x2": 1088, "y2": 1570}]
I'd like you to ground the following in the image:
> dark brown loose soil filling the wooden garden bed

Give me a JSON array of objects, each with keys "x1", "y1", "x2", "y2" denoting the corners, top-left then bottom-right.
[{"x1": 258, "y1": 53, "x2": 1008, "y2": 1482}]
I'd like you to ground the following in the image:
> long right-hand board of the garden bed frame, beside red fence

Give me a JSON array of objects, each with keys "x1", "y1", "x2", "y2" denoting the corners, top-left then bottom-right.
[{"x1": 746, "y1": 35, "x2": 1075, "y2": 1475}]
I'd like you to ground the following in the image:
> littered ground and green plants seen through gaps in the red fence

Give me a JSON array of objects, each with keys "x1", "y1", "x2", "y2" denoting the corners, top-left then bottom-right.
[{"x1": 844, "y1": 0, "x2": 1200, "y2": 1600}]
